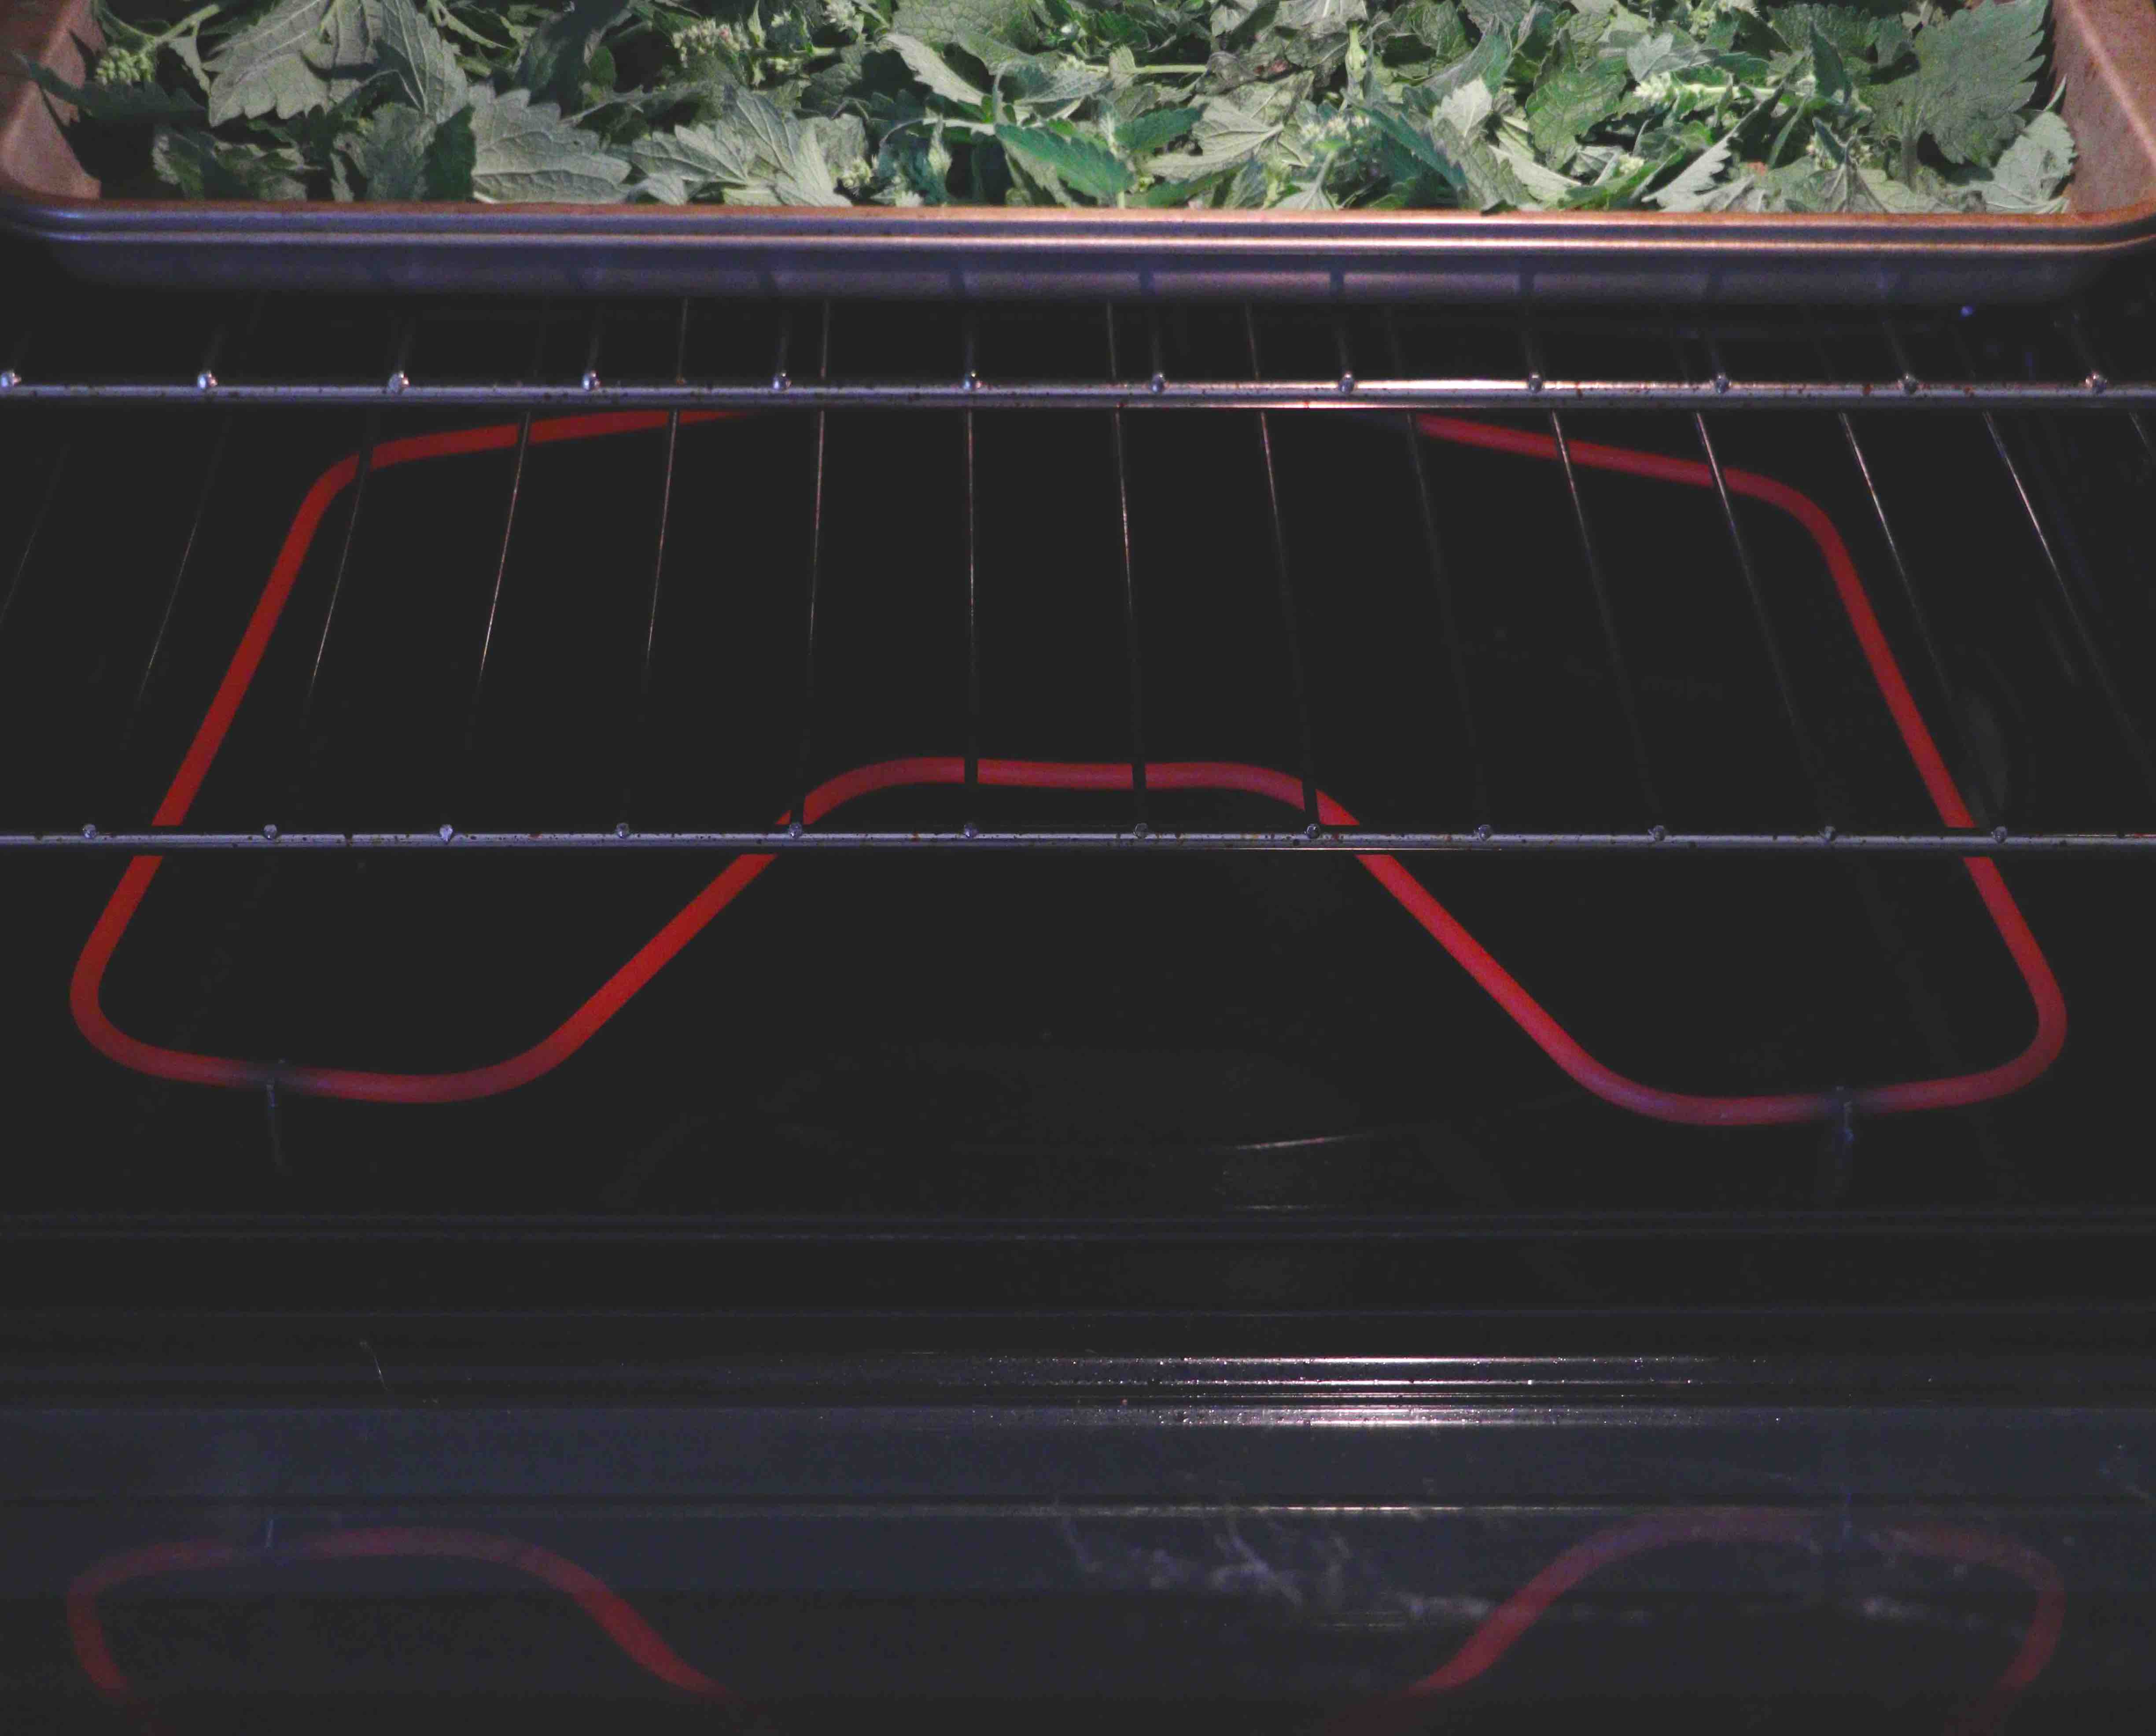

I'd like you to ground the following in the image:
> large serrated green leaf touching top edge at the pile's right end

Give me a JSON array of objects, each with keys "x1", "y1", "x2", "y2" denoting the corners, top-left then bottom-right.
[{"x1": 1873, "y1": 0, "x2": 2046, "y2": 164}]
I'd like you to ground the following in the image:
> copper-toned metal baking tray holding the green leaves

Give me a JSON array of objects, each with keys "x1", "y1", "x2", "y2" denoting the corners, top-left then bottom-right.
[{"x1": 0, "y1": 0, "x2": 2156, "y2": 302}]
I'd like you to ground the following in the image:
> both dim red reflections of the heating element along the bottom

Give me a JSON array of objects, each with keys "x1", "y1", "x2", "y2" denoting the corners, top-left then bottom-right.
[{"x1": 67, "y1": 1508, "x2": 2065, "y2": 1736}]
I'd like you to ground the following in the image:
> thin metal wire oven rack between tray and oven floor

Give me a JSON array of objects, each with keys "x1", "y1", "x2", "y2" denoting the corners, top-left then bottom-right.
[{"x1": 0, "y1": 285, "x2": 2156, "y2": 861}]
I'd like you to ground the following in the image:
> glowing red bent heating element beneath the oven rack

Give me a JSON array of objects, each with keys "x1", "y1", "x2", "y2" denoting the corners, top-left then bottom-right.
[{"x1": 69, "y1": 412, "x2": 2065, "y2": 1125}]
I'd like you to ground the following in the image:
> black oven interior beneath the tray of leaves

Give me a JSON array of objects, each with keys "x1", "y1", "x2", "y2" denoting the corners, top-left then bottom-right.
[{"x1": 0, "y1": 252, "x2": 2156, "y2": 1732}]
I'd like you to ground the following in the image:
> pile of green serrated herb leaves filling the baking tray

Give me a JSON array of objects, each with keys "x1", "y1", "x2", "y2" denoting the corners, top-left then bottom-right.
[{"x1": 17, "y1": 0, "x2": 2074, "y2": 211}]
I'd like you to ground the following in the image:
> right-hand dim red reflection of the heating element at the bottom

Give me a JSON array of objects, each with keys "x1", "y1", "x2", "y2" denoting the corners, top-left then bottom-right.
[{"x1": 1326, "y1": 1508, "x2": 2065, "y2": 1736}]
